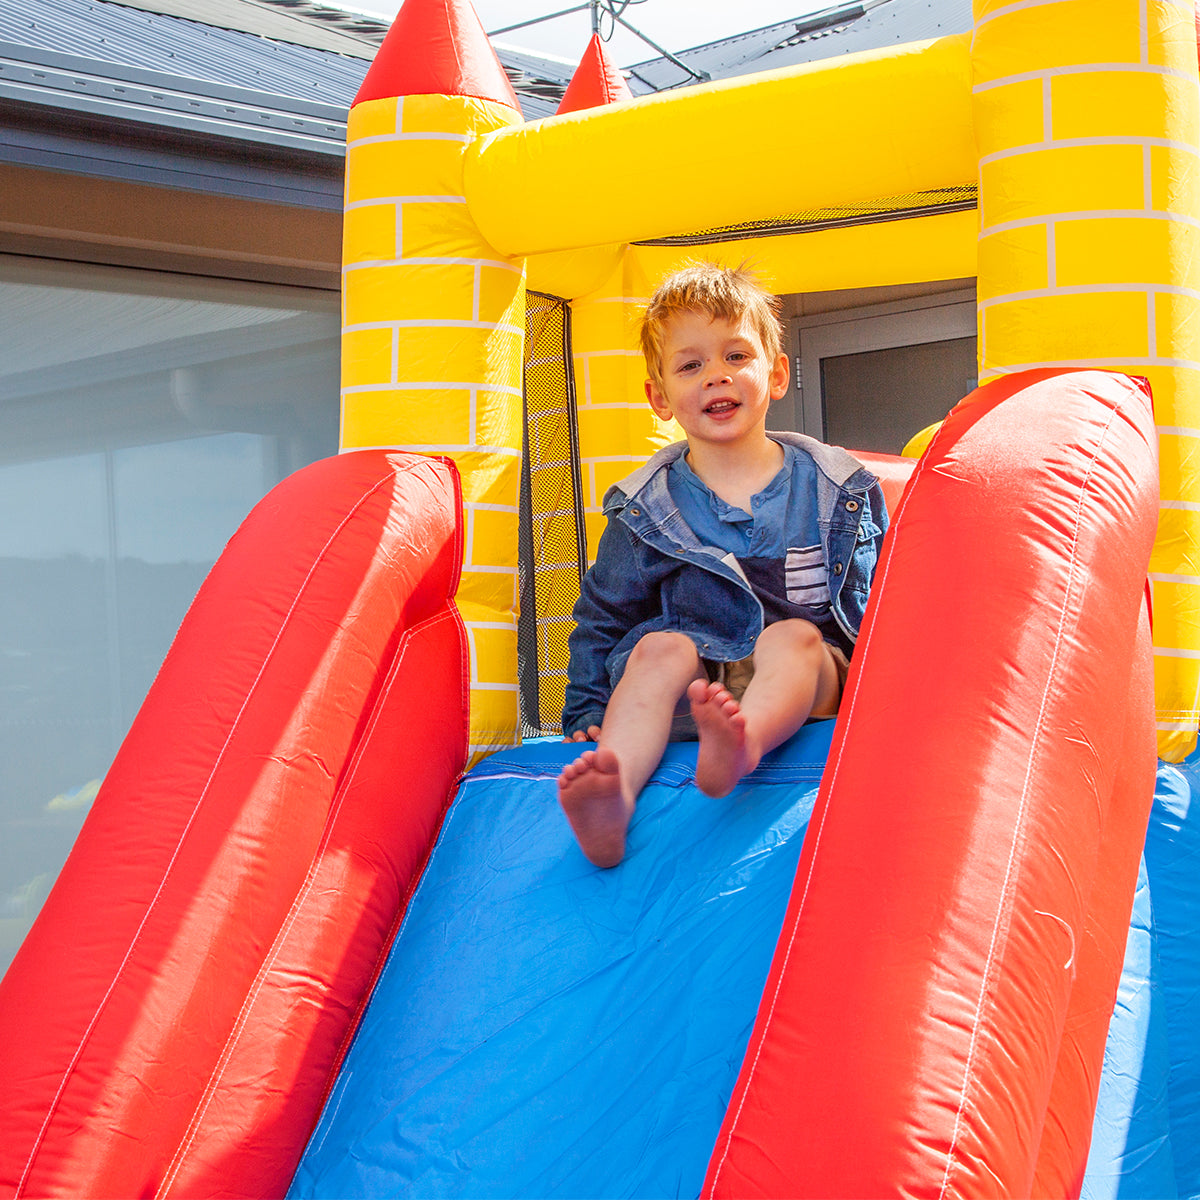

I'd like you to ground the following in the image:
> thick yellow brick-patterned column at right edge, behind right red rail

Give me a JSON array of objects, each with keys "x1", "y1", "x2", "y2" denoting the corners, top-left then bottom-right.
[{"x1": 972, "y1": 0, "x2": 1200, "y2": 761}]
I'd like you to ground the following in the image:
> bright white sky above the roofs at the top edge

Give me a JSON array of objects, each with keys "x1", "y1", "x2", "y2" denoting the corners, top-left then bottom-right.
[{"x1": 325, "y1": 0, "x2": 835, "y2": 66}]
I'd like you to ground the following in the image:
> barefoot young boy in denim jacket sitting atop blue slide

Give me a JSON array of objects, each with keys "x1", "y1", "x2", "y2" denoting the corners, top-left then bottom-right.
[{"x1": 558, "y1": 264, "x2": 887, "y2": 866}]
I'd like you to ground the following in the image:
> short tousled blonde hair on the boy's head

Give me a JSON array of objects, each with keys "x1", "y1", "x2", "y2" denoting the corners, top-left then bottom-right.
[{"x1": 640, "y1": 263, "x2": 784, "y2": 388}]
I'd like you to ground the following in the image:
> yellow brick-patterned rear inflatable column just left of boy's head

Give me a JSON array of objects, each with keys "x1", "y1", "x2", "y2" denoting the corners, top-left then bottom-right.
[{"x1": 571, "y1": 248, "x2": 682, "y2": 562}]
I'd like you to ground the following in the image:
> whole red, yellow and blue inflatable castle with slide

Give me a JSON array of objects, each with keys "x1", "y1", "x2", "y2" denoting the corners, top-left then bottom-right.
[{"x1": 0, "y1": 0, "x2": 1200, "y2": 1198}]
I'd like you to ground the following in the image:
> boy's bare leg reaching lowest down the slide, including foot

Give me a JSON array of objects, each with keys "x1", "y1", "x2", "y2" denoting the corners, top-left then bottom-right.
[{"x1": 558, "y1": 631, "x2": 704, "y2": 866}]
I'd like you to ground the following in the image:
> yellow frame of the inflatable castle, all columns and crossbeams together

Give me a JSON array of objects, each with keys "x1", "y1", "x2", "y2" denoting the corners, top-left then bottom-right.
[{"x1": 342, "y1": 0, "x2": 1200, "y2": 761}]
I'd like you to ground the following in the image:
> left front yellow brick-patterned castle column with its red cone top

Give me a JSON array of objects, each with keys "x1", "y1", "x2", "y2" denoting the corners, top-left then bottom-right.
[{"x1": 341, "y1": 0, "x2": 524, "y2": 761}]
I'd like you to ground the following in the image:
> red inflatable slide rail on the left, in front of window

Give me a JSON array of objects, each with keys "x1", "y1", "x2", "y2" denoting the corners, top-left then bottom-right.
[{"x1": 0, "y1": 451, "x2": 467, "y2": 1196}]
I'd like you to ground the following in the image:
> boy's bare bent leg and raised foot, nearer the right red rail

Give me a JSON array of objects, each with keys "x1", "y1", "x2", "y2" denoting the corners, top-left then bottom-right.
[{"x1": 688, "y1": 620, "x2": 841, "y2": 796}]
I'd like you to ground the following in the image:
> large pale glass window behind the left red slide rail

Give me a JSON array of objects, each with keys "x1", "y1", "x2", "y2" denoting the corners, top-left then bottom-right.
[{"x1": 0, "y1": 256, "x2": 338, "y2": 971}]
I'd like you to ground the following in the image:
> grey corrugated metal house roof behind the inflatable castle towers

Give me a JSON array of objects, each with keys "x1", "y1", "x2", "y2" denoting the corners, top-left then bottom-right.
[{"x1": 0, "y1": 0, "x2": 971, "y2": 210}]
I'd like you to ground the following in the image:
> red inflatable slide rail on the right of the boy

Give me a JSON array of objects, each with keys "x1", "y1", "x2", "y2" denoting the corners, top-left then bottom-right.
[{"x1": 703, "y1": 371, "x2": 1158, "y2": 1200}]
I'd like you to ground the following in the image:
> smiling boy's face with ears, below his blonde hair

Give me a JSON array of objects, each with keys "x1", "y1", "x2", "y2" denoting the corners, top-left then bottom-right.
[{"x1": 646, "y1": 312, "x2": 787, "y2": 446}]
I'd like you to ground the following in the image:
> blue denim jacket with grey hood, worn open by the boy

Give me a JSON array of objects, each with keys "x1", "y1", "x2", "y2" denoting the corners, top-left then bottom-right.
[{"x1": 563, "y1": 433, "x2": 888, "y2": 734}]
